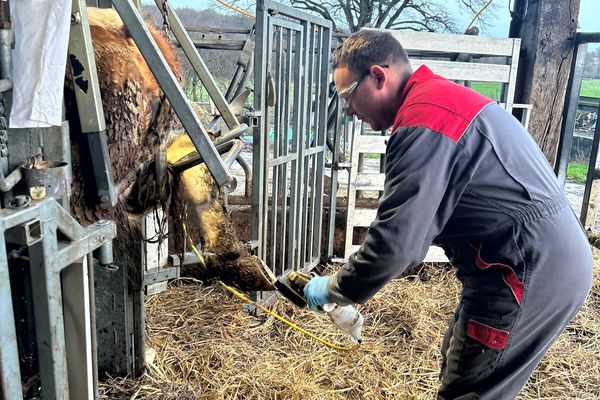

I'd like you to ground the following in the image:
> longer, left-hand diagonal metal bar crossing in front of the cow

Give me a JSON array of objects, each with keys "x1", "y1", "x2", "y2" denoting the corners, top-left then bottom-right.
[{"x1": 113, "y1": 0, "x2": 232, "y2": 186}]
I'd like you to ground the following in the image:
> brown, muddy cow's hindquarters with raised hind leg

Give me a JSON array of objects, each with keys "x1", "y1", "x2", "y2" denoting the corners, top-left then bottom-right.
[{"x1": 65, "y1": 8, "x2": 272, "y2": 289}]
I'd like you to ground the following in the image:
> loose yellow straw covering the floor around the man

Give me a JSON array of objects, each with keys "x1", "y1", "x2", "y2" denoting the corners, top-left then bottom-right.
[{"x1": 100, "y1": 252, "x2": 600, "y2": 400}]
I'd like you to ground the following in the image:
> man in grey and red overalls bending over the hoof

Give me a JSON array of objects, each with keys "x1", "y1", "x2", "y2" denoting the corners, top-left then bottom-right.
[{"x1": 305, "y1": 30, "x2": 592, "y2": 400}]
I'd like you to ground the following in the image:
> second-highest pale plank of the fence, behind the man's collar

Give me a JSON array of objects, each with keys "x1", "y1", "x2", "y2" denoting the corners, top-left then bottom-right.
[{"x1": 410, "y1": 59, "x2": 511, "y2": 83}]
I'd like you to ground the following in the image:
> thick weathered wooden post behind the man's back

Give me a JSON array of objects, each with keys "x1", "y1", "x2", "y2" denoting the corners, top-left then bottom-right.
[{"x1": 509, "y1": 0, "x2": 580, "y2": 165}]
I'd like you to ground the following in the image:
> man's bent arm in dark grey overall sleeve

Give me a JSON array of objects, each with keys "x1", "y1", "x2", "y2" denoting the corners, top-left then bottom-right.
[{"x1": 328, "y1": 127, "x2": 473, "y2": 305}]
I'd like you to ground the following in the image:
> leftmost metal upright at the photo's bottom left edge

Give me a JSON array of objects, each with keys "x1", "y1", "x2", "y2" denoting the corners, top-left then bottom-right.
[{"x1": 0, "y1": 227, "x2": 23, "y2": 399}]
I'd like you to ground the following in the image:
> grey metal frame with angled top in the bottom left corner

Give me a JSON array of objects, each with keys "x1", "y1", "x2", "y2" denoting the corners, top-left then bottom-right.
[{"x1": 0, "y1": 199, "x2": 116, "y2": 399}]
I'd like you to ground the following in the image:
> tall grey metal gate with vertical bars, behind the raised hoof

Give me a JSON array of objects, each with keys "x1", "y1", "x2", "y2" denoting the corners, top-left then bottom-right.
[{"x1": 252, "y1": 0, "x2": 331, "y2": 275}]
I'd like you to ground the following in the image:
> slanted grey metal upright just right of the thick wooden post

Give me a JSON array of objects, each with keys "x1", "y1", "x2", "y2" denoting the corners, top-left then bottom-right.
[{"x1": 554, "y1": 43, "x2": 587, "y2": 186}]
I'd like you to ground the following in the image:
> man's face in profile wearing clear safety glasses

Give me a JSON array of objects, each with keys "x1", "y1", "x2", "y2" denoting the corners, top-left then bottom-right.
[{"x1": 333, "y1": 65, "x2": 393, "y2": 130}]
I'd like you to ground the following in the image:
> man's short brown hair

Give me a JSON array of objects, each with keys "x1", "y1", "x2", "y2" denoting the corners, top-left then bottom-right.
[{"x1": 331, "y1": 29, "x2": 409, "y2": 73}]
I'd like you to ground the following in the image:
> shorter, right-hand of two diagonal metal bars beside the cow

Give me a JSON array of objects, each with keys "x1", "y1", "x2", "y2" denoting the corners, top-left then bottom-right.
[{"x1": 154, "y1": 0, "x2": 240, "y2": 130}]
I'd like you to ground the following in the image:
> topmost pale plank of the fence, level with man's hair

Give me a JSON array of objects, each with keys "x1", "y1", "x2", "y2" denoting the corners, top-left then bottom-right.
[{"x1": 388, "y1": 30, "x2": 514, "y2": 56}]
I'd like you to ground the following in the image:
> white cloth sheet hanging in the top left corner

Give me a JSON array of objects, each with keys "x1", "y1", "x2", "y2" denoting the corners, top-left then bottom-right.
[{"x1": 10, "y1": 0, "x2": 72, "y2": 128}]
